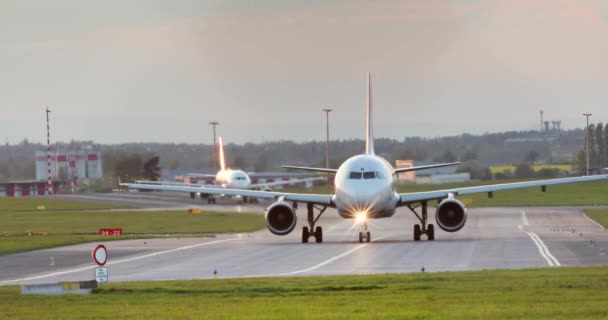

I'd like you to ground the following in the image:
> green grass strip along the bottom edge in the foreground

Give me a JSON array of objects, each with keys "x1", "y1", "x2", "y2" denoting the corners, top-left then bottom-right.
[{"x1": 0, "y1": 267, "x2": 608, "y2": 320}]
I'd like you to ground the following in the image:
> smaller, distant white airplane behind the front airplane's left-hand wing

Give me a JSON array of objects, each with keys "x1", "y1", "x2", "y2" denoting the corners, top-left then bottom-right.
[{"x1": 132, "y1": 137, "x2": 326, "y2": 204}]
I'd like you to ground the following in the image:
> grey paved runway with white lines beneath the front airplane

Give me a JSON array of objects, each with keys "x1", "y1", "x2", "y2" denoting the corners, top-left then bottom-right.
[{"x1": 0, "y1": 194, "x2": 608, "y2": 285}]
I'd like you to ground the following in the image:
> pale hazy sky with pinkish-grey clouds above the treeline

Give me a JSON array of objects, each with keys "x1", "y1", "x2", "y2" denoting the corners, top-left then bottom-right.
[{"x1": 0, "y1": 0, "x2": 608, "y2": 144}]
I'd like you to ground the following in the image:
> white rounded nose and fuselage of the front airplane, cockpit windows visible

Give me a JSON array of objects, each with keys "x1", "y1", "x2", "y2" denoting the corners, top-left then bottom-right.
[{"x1": 333, "y1": 154, "x2": 399, "y2": 219}]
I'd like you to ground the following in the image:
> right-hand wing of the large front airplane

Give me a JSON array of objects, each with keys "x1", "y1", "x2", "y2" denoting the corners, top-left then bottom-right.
[{"x1": 398, "y1": 174, "x2": 608, "y2": 206}]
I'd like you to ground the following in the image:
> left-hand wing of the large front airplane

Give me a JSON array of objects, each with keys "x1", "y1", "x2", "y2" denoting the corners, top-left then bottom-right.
[{"x1": 121, "y1": 183, "x2": 335, "y2": 208}]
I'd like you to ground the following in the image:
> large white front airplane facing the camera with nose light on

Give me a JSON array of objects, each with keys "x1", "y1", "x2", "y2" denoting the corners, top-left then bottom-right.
[{"x1": 126, "y1": 73, "x2": 608, "y2": 243}]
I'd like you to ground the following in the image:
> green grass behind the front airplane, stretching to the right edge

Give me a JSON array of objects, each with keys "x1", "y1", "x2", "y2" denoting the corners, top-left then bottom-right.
[{"x1": 285, "y1": 180, "x2": 608, "y2": 207}]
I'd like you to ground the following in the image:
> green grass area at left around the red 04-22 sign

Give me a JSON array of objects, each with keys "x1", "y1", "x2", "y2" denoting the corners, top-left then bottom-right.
[{"x1": 0, "y1": 198, "x2": 265, "y2": 255}]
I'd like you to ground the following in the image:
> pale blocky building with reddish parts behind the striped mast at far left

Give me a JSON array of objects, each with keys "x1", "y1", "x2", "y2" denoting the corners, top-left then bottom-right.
[{"x1": 36, "y1": 148, "x2": 103, "y2": 181}]
